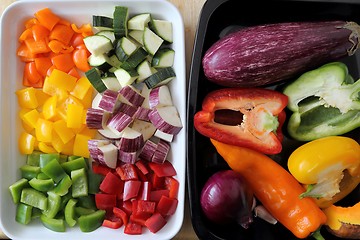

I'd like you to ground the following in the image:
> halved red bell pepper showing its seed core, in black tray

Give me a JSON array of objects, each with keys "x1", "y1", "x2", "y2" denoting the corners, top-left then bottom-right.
[{"x1": 194, "y1": 88, "x2": 288, "y2": 154}]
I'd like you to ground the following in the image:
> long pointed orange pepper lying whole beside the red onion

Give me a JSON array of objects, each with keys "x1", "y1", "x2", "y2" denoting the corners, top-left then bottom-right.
[{"x1": 211, "y1": 139, "x2": 326, "y2": 238}]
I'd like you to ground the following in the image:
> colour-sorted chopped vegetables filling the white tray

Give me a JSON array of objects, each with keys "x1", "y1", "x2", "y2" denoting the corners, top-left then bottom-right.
[{"x1": 9, "y1": 6, "x2": 183, "y2": 235}]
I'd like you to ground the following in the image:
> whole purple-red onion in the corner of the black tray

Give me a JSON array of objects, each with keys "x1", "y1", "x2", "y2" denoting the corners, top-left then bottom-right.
[{"x1": 200, "y1": 170, "x2": 253, "y2": 228}]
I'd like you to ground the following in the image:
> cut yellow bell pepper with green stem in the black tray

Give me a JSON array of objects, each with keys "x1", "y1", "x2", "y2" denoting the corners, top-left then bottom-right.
[{"x1": 288, "y1": 136, "x2": 360, "y2": 208}]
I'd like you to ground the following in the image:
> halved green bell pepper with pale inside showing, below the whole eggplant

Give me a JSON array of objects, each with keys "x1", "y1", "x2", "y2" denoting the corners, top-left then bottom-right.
[{"x1": 283, "y1": 62, "x2": 360, "y2": 141}]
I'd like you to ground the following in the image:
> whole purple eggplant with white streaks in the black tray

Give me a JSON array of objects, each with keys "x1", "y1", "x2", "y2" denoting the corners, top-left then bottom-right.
[{"x1": 202, "y1": 21, "x2": 360, "y2": 87}]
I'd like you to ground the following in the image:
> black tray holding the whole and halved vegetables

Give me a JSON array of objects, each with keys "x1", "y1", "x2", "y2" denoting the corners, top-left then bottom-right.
[{"x1": 187, "y1": 0, "x2": 360, "y2": 240}]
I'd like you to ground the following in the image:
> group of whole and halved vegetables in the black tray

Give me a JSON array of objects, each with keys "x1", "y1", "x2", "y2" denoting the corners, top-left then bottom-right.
[{"x1": 194, "y1": 21, "x2": 360, "y2": 239}]
